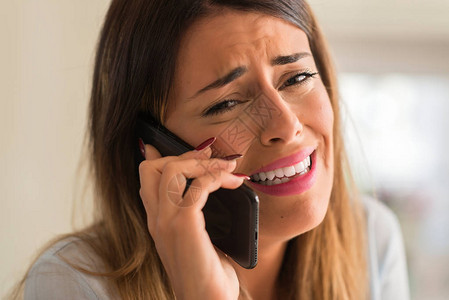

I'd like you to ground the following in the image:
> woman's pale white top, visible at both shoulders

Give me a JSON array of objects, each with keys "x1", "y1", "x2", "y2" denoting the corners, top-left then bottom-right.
[{"x1": 24, "y1": 198, "x2": 410, "y2": 300}]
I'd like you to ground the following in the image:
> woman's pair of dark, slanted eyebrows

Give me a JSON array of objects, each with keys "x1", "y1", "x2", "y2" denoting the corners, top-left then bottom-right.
[{"x1": 189, "y1": 52, "x2": 312, "y2": 99}]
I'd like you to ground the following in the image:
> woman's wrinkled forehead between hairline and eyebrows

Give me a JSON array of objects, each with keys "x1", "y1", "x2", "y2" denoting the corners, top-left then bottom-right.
[{"x1": 172, "y1": 11, "x2": 310, "y2": 95}]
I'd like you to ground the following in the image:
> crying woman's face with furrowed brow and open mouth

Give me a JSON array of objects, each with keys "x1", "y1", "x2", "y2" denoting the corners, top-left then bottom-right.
[{"x1": 165, "y1": 11, "x2": 334, "y2": 243}]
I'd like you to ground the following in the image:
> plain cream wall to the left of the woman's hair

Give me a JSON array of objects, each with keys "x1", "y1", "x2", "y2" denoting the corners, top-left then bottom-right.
[{"x1": 0, "y1": 0, "x2": 109, "y2": 298}]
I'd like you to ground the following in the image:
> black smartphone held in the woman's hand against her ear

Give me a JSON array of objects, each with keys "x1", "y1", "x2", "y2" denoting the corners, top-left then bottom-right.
[{"x1": 136, "y1": 115, "x2": 259, "y2": 269}]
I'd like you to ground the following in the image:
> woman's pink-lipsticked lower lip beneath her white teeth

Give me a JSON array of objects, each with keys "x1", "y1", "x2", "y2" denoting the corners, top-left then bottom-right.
[{"x1": 248, "y1": 152, "x2": 317, "y2": 196}]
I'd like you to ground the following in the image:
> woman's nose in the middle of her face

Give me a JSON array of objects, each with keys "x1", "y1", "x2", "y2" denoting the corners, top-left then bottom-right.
[{"x1": 250, "y1": 89, "x2": 303, "y2": 146}]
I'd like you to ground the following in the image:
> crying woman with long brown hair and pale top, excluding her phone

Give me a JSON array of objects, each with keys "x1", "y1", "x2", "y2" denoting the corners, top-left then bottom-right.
[{"x1": 16, "y1": 0, "x2": 408, "y2": 299}]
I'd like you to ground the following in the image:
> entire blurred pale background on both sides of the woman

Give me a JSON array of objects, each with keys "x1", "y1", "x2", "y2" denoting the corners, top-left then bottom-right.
[{"x1": 0, "y1": 0, "x2": 449, "y2": 300}]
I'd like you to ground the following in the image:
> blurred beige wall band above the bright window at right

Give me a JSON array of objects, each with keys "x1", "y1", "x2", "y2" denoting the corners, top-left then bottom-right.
[{"x1": 309, "y1": 0, "x2": 449, "y2": 75}]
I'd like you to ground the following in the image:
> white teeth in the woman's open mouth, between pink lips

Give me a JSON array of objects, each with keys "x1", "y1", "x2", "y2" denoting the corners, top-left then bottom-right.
[{"x1": 250, "y1": 155, "x2": 312, "y2": 185}]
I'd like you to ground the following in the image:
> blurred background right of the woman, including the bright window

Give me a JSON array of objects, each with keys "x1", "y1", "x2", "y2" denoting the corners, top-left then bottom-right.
[{"x1": 310, "y1": 0, "x2": 449, "y2": 300}]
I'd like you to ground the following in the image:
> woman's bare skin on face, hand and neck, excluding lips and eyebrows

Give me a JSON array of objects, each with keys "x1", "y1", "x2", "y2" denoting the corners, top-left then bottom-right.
[{"x1": 140, "y1": 11, "x2": 333, "y2": 299}]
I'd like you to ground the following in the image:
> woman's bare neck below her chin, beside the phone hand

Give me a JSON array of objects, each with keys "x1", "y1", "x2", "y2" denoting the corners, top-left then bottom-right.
[{"x1": 234, "y1": 242, "x2": 287, "y2": 300}]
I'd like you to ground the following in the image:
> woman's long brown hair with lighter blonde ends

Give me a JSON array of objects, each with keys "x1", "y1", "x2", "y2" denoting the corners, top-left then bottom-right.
[{"x1": 12, "y1": 0, "x2": 368, "y2": 300}]
